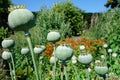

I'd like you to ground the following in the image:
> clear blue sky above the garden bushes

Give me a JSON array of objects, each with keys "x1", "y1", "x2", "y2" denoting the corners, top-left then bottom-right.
[{"x1": 12, "y1": 0, "x2": 107, "y2": 13}]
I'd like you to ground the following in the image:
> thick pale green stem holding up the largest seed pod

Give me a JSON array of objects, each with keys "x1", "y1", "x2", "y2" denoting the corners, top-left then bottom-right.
[{"x1": 26, "y1": 34, "x2": 39, "y2": 80}]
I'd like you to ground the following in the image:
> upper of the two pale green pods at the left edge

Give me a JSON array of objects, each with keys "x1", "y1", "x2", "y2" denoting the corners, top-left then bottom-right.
[{"x1": 2, "y1": 38, "x2": 15, "y2": 48}]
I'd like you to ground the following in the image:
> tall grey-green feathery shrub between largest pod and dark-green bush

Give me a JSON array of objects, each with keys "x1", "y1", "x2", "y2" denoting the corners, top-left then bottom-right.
[{"x1": 32, "y1": 8, "x2": 71, "y2": 44}]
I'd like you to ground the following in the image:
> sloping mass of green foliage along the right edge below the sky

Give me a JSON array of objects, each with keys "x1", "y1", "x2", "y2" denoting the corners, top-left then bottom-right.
[{"x1": 82, "y1": 8, "x2": 120, "y2": 53}]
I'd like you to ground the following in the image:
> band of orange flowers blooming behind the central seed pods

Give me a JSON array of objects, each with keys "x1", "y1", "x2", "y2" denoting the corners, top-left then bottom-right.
[{"x1": 44, "y1": 38, "x2": 105, "y2": 58}]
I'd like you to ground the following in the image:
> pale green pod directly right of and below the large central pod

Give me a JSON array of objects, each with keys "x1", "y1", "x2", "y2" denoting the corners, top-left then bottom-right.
[{"x1": 78, "y1": 53, "x2": 93, "y2": 65}]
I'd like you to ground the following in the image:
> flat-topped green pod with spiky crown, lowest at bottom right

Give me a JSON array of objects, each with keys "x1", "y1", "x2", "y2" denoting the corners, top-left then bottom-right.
[{"x1": 94, "y1": 66, "x2": 108, "y2": 75}]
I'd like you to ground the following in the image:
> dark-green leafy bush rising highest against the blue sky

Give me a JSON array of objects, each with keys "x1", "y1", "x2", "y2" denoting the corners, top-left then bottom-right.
[{"x1": 51, "y1": 1, "x2": 83, "y2": 35}]
